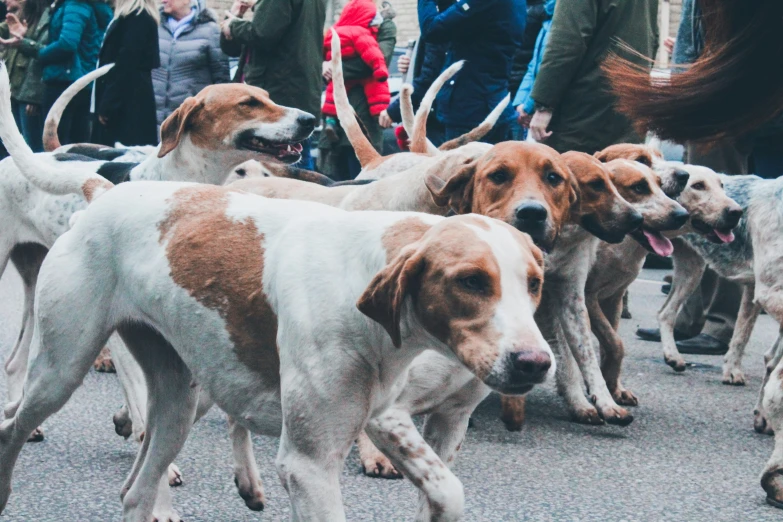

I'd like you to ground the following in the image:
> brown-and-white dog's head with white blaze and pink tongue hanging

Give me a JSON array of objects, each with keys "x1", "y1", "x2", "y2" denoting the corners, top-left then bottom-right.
[{"x1": 606, "y1": 159, "x2": 688, "y2": 256}]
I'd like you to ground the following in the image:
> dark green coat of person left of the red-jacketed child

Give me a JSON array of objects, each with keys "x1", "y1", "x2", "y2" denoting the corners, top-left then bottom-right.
[{"x1": 220, "y1": 0, "x2": 326, "y2": 116}]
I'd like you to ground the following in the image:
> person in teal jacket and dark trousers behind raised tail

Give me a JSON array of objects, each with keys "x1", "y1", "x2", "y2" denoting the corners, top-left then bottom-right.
[{"x1": 32, "y1": 0, "x2": 111, "y2": 144}]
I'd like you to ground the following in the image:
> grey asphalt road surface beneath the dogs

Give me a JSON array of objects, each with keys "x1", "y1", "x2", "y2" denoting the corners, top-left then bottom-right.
[{"x1": 0, "y1": 268, "x2": 783, "y2": 522}]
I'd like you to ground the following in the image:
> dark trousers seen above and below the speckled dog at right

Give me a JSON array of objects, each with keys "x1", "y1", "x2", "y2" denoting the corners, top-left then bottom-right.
[{"x1": 675, "y1": 143, "x2": 748, "y2": 343}]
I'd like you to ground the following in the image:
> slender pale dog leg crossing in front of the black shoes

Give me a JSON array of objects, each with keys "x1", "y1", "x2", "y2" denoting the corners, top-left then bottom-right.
[{"x1": 658, "y1": 238, "x2": 707, "y2": 372}]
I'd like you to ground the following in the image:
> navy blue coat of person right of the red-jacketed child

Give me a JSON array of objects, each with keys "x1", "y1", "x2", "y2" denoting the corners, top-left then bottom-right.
[{"x1": 419, "y1": 0, "x2": 526, "y2": 127}]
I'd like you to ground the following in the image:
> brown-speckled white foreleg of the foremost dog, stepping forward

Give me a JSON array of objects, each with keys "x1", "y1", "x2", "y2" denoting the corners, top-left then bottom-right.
[{"x1": 365, "y1": 407, "x2": 467, "y2": 521}]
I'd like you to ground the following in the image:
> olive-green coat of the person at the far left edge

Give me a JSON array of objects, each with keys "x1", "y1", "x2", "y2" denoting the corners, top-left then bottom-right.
[{"x1": 8, "y1": 7, "x2": 50, "y2": 105}]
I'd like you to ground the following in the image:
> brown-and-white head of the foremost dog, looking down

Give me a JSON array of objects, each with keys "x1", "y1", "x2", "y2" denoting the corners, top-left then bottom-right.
[{"x1": 357, "y1": 215, "x2": 555, "y2": 394}]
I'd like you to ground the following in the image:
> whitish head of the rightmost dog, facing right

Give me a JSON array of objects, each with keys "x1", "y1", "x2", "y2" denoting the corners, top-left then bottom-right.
[{"x1": 678, "y1": 165, "x2": 742, "y2": 244}]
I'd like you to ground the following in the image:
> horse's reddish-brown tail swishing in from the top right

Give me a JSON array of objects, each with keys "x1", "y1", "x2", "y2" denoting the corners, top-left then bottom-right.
[{"x1": 603, "y1": 0, "x2": 783, "y2": 142}]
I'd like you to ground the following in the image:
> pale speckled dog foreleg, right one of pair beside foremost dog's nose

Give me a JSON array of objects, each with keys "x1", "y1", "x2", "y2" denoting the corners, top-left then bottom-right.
[{"x1": 558, "y1": 285, "x2": 633, "y2": 426}]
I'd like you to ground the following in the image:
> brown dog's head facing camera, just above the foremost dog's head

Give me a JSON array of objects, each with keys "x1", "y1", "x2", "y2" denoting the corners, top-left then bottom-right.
[{"x1": 427, "y1": 141, "x2": 578, "y2": 250}]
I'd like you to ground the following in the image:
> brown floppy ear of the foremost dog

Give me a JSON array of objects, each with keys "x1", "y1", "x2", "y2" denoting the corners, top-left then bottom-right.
[{"x1": 356, "y1": 244, "x2": 424, "y2": 348}]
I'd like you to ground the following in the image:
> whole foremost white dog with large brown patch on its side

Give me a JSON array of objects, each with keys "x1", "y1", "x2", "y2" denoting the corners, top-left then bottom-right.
[{"x1": 0, "y1": 132, "x2": 554, "y2": 522}]
